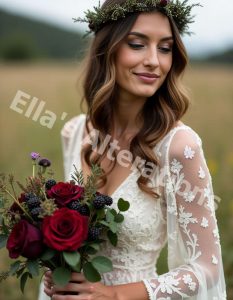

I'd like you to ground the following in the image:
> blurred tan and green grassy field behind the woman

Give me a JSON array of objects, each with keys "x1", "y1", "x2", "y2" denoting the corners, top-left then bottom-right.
[{"x1": 0, "y1": 62, "x2": 233, "y2": 300}]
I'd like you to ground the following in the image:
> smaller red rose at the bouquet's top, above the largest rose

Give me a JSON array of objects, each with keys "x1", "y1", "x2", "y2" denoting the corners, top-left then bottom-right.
[{"x1": 47, "y1": 182, "x2": 84, "y2": 207}]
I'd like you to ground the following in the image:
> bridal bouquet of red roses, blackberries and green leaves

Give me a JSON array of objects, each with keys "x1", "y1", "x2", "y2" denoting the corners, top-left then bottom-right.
[{"x1": 0, "y1": 152, "x2": 129, "y2": 291}]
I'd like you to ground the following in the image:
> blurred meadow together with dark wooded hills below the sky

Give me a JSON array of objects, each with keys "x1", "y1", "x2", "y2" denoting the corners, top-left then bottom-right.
[{"x1": 0, "y1": 7, "x2": 233, "y2": 300}]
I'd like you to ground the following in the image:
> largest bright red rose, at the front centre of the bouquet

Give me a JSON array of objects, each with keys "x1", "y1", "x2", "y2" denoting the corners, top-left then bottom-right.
[{"x1": 42, "y1": 207, "x2": 88, "y2": 251}]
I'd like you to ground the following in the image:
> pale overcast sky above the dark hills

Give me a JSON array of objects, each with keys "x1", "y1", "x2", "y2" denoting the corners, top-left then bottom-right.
[{"x1": 0, "y1": 0, "x2": 233, "y2": 55}]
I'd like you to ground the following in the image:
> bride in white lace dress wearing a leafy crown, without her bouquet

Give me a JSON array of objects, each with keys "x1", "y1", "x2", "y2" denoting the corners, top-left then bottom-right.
[{"x1": 40, "y1": 0, "x2": 226, "y2": 300}]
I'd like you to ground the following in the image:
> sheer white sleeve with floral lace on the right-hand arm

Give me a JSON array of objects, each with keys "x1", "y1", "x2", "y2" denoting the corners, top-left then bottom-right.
[{"x1": 144, "y1": 130, "x2": 226, "y2": 300}]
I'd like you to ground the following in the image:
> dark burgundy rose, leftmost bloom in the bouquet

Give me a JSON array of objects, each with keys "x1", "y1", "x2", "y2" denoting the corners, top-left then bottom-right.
[{"x1": 6, "y1": 220, "x2": 43, "y2": 259}]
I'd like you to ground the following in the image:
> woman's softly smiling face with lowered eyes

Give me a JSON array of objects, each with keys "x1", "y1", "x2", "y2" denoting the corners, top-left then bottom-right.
[{"x1": 115, "y1": 12, "x2": 173, "y2": 98}]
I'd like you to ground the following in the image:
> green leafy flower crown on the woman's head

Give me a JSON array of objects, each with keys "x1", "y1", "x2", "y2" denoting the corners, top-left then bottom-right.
[{"x1": 74, "y1": 0, "x2": 201, "y2": 34}]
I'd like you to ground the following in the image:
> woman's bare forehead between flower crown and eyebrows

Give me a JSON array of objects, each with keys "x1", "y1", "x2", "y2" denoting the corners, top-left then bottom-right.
[{"x1": 130, "y1": 11, "x2": 172, "y2": 38}]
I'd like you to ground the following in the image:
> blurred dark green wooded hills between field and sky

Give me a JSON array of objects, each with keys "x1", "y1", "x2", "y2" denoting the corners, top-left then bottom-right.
[{"x1": 0, "y1": 10, "x2": 233, "y2": 64}]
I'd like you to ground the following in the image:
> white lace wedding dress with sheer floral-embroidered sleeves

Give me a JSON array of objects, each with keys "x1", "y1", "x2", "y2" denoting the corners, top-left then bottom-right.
[{"x1": 39, "y1": 114, "x2": 226, "y2": 300}]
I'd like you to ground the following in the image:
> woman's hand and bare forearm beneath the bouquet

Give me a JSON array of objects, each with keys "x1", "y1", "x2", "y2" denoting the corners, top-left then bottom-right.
[{"x1": 44, "y1": 272, "x2": 117, "y2": 300}]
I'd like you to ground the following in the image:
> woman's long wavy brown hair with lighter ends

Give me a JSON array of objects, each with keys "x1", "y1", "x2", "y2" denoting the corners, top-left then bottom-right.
[{"x1": 82, "y1": 0, "x2": 189, "y2": 197}]
